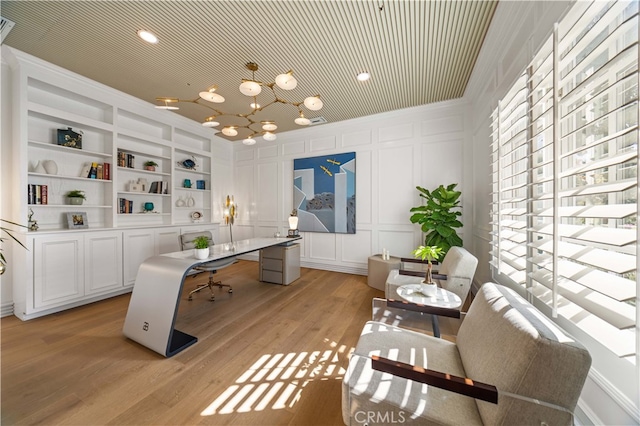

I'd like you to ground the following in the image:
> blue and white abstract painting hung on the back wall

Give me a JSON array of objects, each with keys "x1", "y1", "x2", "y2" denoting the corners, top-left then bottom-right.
[{"x1": 293, "y1": 152, "x2": 356, "y2": 234}]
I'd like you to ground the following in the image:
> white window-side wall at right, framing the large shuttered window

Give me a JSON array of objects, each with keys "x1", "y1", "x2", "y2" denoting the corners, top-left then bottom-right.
[{"x1": 464, "y1": 1, "x2": 640, "y2": 425}]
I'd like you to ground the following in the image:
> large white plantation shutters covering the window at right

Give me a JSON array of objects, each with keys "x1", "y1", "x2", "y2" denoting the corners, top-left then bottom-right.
[{"x1": 491, "y1": 1, "x2": 640, "y2": 362}]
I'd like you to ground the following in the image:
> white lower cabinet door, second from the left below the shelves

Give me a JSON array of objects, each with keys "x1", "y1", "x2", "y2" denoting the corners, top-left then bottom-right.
[{"x1": 84, "y1": 231, "x2": 122, "y2": 295}]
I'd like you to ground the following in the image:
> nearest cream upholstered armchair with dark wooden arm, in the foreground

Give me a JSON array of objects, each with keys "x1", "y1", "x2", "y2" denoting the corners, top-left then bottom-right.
[{"x1": 342, "y1": 283, "x2": 591, "y2": 425}]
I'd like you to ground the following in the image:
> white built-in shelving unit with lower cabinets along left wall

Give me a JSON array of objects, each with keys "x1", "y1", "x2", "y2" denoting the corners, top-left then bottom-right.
[{"x1": 2, "y1": 46, "x2": 224, "y2": 319}]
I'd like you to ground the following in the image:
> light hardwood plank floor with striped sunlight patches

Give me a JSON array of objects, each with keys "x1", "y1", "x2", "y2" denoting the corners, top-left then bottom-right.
[{"x1": 1, "y1": 261, "x2": 383, "y2": 425}]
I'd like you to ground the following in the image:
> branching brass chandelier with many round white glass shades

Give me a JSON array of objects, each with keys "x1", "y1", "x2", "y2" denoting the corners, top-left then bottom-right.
[{"x1": 156, "y1": 62, "x2": 322, "y2": 145}]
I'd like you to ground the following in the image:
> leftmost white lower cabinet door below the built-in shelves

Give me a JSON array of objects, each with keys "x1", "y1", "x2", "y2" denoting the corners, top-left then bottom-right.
[{"x1": 33, "y1": 233, "x2": 84, "y2": 309}]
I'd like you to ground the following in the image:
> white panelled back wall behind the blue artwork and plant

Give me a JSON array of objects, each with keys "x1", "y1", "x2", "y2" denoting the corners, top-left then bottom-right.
[{"x1": 228, "y1": 100, "x2": 471, "y2": 274}]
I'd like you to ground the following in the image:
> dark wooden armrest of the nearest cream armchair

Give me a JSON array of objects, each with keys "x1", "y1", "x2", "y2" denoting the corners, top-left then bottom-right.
[{"x1": 371, "y1": 355, "x2": 498, "y2": 404}]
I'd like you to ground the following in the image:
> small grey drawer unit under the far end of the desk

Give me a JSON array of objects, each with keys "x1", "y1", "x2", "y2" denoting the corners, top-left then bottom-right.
[{"x1": 260, "y1": 244, "x2": 300, "y2": 285}]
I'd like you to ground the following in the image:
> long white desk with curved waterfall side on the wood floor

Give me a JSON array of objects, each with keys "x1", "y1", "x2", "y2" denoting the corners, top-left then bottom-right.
[{"x1": 122, "y1": 237, "x2": 302, "y2": 357}]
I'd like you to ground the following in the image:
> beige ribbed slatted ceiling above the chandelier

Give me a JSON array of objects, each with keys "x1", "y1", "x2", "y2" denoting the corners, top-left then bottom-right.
[{"x1": 0, "y1": 0, "x2": 497, "y2": 139}]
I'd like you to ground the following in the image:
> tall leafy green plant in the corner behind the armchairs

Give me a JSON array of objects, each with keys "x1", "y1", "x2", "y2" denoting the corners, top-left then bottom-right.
[{"x1": 410, "y1": 183, "x2": 462, "y2": 256}]
